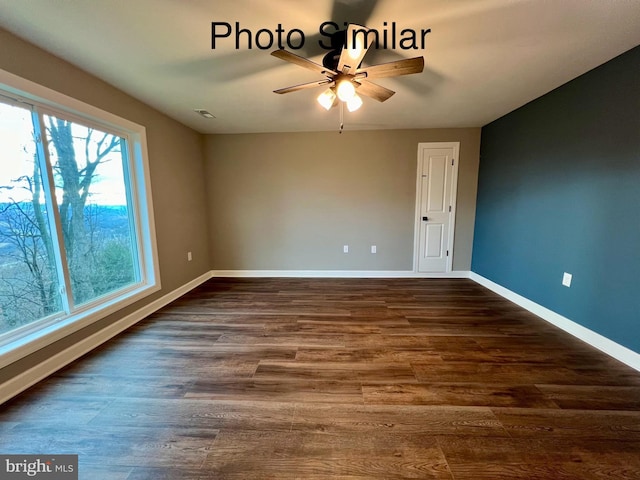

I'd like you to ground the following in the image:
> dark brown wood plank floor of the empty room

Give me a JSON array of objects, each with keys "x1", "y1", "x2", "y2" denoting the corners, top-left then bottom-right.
[{"x1": 0, "y1": 279, "x2": 640, "y2": 480}]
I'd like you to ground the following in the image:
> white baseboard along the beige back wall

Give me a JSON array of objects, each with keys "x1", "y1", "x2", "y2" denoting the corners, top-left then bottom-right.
[{"x1": 211, "y1": 270, "x2": 471, "y2": 278}]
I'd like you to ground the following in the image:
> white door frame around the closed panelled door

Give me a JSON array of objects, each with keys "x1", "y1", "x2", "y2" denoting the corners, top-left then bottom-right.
[{"x1": 413, "y1": 142, "x2": 460, "y2": 276}]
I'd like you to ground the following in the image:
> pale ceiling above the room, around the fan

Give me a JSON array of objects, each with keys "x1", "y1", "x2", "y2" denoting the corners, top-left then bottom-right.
[{"x1": 0, "y1": 0, "x2": 640, "y2": 133}]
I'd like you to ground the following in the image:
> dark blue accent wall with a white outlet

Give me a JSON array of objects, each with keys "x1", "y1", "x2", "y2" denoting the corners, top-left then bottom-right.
[{"x1": 471, "y1": 46, "x2": 640, "y2": 353}]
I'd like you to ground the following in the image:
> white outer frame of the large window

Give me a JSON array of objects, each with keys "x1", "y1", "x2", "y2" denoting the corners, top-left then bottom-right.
[{"x1": 0, "y1": 69, "x2": 161, "y2": 368}]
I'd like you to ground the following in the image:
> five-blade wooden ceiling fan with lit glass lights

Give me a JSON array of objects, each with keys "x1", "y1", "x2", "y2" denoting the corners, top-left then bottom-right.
[{"x1": 271, "y1": 24, "x2": 424, "y2": 112}]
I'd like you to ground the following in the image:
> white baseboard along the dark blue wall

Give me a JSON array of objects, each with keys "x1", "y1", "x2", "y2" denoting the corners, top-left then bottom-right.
[{"x1": 469, "y1": 272, "x2": 640, "y2": 371}]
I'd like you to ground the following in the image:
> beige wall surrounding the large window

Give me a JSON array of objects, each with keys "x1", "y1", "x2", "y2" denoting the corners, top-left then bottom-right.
[{"x1": 0, "y1": 29, "x2": 210, "y2": 383}]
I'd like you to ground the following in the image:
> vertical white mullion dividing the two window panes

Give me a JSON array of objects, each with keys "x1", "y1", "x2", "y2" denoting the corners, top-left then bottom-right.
[{"x1": 31, "y1": 109, "x2": 73, "y2": 314}]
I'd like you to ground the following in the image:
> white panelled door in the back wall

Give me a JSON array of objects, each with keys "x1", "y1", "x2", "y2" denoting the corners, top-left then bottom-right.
[{"x1": 416, "y1": 143, "x2": 460, "y2": 273}]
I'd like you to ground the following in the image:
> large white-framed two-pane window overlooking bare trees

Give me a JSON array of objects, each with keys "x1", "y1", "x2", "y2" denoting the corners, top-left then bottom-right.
[{"x1": 0, "y1": 73, "x2": 158, "y2": 362}]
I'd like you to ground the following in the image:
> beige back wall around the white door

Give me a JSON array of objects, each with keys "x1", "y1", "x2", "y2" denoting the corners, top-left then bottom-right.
[{"x1": 205, "y1": 128, "x2": 480, "y2": 270}]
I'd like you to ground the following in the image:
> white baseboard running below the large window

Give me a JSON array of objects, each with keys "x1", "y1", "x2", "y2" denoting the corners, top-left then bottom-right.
[{"x1": 0, "y1": 271, "x2": 211, "y2": 405}]
